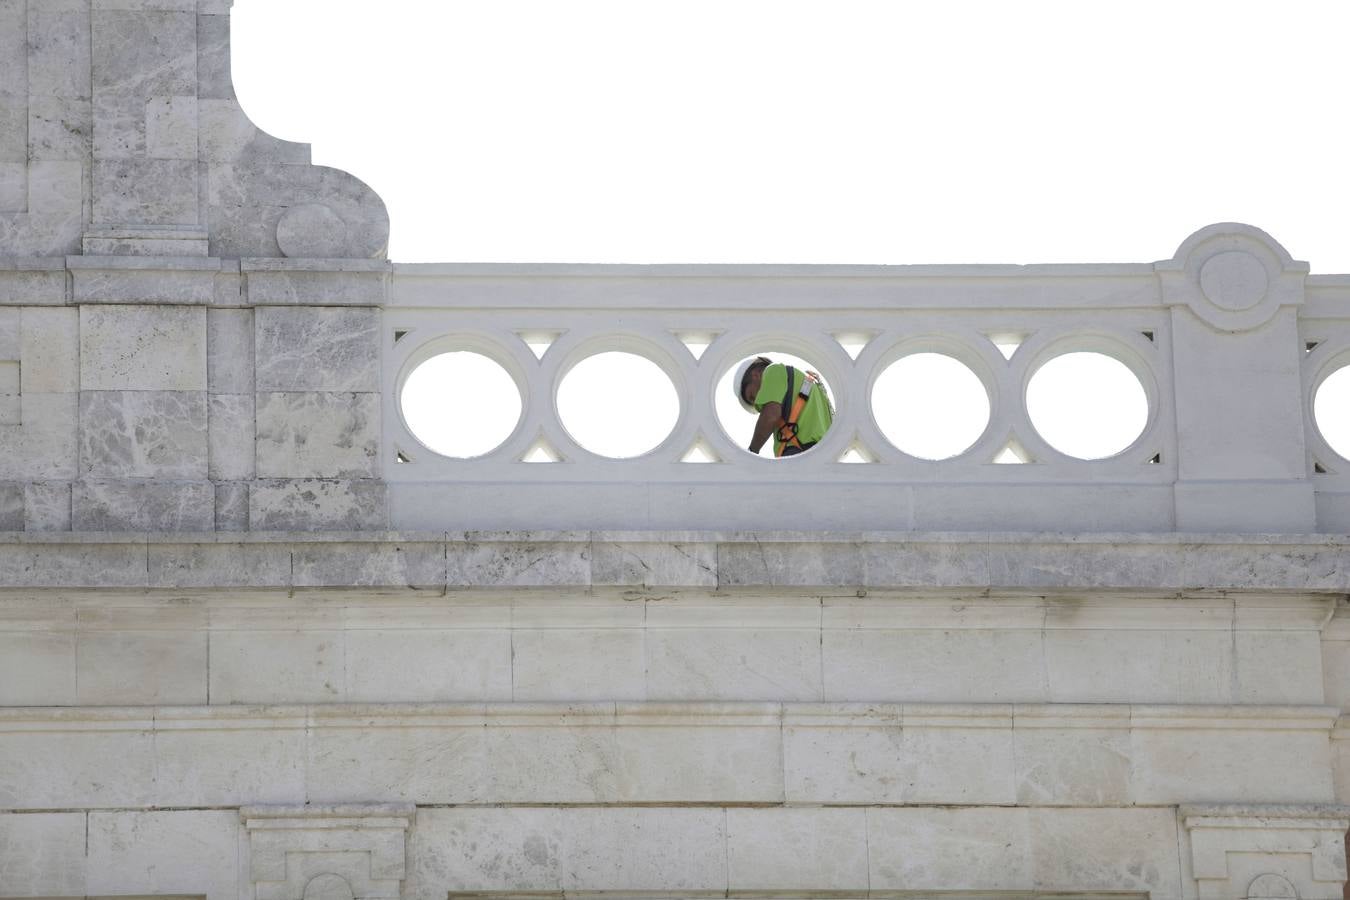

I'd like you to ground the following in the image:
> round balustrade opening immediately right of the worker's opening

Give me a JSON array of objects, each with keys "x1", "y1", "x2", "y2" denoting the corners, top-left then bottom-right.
[{"x1": 872, "y1": 352, "x2": 990, "y2": 460}]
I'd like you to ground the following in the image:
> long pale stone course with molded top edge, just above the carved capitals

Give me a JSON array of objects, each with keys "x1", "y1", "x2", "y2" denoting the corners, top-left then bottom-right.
[{"x1": 0, "y1": 702, "x2": 1337, "y2": 811}]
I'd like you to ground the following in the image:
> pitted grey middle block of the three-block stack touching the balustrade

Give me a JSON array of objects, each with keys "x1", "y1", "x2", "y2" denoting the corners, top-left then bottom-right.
[{"x1": 257, "y1": 393, "x2": 381, "y2": 478}]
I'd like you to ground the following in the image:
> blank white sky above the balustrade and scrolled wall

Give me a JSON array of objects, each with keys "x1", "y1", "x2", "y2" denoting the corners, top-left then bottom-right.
[{"x1": 234, "y1": 0, "x2": 1350, "y2": 273}]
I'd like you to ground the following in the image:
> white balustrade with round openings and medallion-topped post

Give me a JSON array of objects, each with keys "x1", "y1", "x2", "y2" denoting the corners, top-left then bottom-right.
[{"x1": 381, "y1": 225, "x2": 1350, "y2": 532}]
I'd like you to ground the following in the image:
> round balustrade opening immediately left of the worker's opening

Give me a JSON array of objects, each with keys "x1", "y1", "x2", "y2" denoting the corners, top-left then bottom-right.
[{"x1": 558, "y1": 351, "x2": 679, "y2": 459}]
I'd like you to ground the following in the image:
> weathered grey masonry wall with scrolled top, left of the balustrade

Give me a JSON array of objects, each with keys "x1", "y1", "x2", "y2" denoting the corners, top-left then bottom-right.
[{"x1": 0, "y1": 0, "x2": 389, "y2": 532}]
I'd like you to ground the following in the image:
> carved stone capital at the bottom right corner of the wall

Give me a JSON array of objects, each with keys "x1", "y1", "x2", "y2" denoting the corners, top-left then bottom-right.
[{"x1": 1181, "y1": 804, "x2": 1350, "y2": 900}]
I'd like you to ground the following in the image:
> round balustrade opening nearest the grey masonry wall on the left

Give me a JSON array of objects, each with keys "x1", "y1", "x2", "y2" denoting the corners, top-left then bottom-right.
[{"x1": 398, "y1": 351, "x2": 521, "y2": 459}]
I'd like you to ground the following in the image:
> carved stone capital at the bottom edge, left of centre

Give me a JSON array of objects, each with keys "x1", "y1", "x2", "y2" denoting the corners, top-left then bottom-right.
[{"x1": 239, "y1": 803, "x2": 416, "y2": 900}]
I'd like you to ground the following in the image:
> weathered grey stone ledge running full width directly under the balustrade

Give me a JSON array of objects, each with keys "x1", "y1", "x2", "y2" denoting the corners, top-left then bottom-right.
[{"x1": 0, "y1": 532, "x2": 1350, "y2": 595}]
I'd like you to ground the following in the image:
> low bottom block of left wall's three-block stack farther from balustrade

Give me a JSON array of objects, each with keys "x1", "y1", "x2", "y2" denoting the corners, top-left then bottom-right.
[{"x1": 72, "y1": 480, "x2": 216, "y2": 532}]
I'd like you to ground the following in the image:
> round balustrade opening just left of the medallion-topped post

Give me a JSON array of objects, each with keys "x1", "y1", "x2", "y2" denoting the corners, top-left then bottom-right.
[{"x1": 1026, "y1": 352, "x2": 1149, "y2": 459}]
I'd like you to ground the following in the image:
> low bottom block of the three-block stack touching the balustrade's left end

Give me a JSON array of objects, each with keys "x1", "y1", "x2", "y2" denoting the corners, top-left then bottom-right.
[{"x1": 248, "y1": 479, "x2": 389, "y2": 532}]
